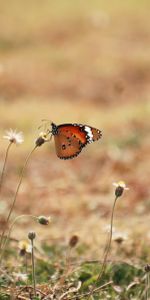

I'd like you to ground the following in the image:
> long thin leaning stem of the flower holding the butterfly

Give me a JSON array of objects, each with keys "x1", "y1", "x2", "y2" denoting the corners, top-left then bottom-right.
[{"x1": 0, "y1": 145, "x2": 37, "y2": 250}]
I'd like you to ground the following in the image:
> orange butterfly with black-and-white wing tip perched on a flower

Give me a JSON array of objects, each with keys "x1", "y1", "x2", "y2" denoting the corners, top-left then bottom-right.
[{"x1": 50, "y1": 122, "x2": 102, "y2": 159}]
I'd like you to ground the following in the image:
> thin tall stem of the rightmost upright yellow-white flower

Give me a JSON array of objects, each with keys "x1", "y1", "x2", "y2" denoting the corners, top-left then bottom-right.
[{"x1": 87, "y1": 197, "x2": 118, "y2": 300}]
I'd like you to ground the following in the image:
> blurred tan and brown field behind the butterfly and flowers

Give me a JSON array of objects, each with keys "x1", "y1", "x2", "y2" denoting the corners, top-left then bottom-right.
[{"x1": 0, "y1": 0, "x2": 150, "y2": 255}]
